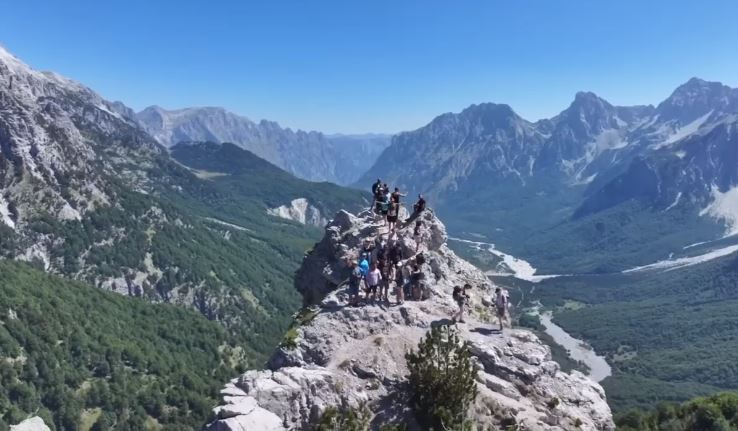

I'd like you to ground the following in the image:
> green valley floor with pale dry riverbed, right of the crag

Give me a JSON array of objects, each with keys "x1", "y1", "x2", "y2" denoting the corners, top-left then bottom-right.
[{"x1": 454, "y1": 238, "x2": 738, "y2": 413}]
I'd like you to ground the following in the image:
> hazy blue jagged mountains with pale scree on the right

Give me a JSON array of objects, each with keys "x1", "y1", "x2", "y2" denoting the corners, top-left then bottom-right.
[{"x1": 356, "y1": 78, "x2": 738, "y2": 272}]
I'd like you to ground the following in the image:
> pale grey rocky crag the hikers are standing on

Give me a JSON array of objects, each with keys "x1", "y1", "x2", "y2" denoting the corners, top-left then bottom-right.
[{"x1": 205, "y1": 211, "x2": 614, "y2": 431}]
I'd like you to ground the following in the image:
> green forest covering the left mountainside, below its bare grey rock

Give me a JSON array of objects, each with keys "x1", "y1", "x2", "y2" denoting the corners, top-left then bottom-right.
[{"x1": 0, "y1": 144, "x2": 365, "y2": 431}]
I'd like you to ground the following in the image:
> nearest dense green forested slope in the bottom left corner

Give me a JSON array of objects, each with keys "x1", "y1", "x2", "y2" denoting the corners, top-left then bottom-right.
[{"x1": 0, "y1": 261, "x2": 237, "y2": 430}]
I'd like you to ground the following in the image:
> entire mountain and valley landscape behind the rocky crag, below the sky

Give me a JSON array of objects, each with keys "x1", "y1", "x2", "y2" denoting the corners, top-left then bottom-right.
[{"x1": 0, "y1": 40, "x2": 738, "y2": 429}]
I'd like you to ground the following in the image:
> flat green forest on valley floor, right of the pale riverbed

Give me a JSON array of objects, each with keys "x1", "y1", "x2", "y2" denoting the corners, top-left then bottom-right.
[{"x1": 504, "y1": 251, "x2": 738, "y2": 412}]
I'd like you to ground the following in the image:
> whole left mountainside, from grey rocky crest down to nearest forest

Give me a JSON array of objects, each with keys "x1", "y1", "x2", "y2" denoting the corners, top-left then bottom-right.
[{"x1": 0, "y1": 44, "x2": 368, "y2": 430}]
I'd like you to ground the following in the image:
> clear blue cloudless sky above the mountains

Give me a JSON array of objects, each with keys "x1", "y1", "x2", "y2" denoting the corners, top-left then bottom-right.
[{"x1": 0, "y1": 0, "x2": 738, "y2": 133}]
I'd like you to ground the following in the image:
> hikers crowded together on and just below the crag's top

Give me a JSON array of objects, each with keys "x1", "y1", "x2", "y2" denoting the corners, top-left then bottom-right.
[{"x1": 349, "y1": 180, "x2": 427, "y2": 306}]
